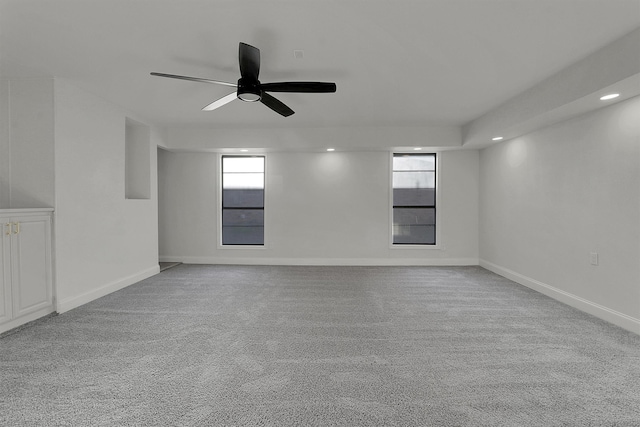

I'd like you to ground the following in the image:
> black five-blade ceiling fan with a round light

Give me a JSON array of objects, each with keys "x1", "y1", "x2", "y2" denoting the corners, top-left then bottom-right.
[{"x1": 151, "y1": 42, "x2": 336, "y2": 117}]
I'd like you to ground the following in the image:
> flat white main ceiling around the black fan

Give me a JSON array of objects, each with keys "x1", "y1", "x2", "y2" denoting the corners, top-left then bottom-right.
[{"x1": 0, "y1": 0, "x2": 640, "y2": 128}]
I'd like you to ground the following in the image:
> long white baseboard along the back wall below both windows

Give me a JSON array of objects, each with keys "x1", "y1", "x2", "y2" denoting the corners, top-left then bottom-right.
[{"x1": 160, "y1": 256, "x2": 478, "y2": 266}]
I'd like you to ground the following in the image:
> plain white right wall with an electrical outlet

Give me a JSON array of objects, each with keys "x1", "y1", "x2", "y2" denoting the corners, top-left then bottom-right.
[{"x1": 480, "y1": 97, "x2": 640, "y2": 333}]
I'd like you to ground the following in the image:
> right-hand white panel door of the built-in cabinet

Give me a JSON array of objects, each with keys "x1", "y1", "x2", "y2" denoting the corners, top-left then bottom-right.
[{"x1": 11, "y1": 216, "x2": 52, "y2": 318}]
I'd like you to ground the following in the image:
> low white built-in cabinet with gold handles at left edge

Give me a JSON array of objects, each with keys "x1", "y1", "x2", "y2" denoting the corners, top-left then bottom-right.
[{"x1": 0, "y1": 209, "x2": 54, "y2": 333}]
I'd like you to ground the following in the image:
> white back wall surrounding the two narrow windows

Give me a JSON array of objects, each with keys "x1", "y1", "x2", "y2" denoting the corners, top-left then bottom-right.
[{"x1": 158, "y1": 149, "x2": 478, "y2": 265}]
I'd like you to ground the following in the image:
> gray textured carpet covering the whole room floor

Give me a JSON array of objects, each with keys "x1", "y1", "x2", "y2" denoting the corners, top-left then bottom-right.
[{"x1": 0, "y1": 265, "x2": 640, "y2": 427}]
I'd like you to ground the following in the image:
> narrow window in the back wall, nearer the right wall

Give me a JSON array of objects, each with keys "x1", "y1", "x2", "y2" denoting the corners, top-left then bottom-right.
[{"x1": 392, "y1": 154, "x2": 436, "y2": 245}]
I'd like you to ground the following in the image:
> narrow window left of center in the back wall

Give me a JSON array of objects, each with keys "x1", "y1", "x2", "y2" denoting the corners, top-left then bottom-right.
[{"x1": 222, "y1": 156, "x2": 264, "y2": 245}]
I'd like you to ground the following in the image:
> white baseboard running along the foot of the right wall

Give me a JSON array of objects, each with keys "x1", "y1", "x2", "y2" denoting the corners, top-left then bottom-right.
[{"x1": 480, "y1": 259, "x2": 640, "y2": 335}]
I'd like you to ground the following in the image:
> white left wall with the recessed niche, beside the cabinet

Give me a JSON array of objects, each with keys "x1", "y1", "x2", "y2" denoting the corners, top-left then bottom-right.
[{"x1": 55, "y1": 80, "x2": 161, "y2": 312}]
